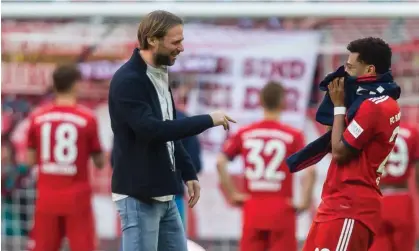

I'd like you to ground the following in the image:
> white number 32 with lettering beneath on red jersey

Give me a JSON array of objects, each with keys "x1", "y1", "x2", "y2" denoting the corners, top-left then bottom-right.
[{"x1": 244, "y1": 139, "x2": 287, "y2": 191}]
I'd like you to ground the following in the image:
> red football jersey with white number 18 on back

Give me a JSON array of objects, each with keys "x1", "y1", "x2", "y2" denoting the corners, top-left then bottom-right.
[{"x1": 28, "y1": 104, "x2": 101, "y2": 214}]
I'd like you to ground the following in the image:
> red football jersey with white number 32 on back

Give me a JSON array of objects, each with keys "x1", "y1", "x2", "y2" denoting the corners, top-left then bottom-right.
[{"x1": 223, "y1": 120, "x2": 305, "y2": 229}]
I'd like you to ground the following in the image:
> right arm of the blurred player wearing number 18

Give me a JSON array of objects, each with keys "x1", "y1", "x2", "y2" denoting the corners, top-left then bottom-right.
[{"x1": 88, "y1": 117, "x2": 105, "y2": 169}]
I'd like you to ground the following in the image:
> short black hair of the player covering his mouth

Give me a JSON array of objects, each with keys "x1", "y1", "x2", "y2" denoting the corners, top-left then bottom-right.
[{"x1": 347, "y1": 37, "x2": 392, "y2": 74}]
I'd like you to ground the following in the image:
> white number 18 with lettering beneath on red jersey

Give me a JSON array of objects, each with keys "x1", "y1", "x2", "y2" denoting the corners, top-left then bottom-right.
[{"x1": 41, "y1": 122, "x2": 78, "y2": 175}]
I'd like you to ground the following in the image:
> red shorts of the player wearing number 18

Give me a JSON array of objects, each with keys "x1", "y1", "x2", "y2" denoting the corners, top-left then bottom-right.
[{"x1": 31, "y1": 206, "x2": 96, "y2": 251}]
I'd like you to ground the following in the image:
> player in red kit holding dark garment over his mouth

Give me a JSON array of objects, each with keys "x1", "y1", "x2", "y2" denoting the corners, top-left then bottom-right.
[{"x1": 303, "y1": 38, "x2": 400, "y2": 251}]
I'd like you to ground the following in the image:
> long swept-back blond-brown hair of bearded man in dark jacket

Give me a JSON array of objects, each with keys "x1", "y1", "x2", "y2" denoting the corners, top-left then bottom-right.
[{"x1": 137, "y1": 10, "x2": 183, "y2": 50}]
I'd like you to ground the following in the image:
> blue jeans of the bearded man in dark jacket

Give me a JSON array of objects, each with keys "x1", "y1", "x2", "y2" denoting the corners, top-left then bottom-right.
[{"x1": 116, "y1": 197, "x2": 188, "y2": 251}]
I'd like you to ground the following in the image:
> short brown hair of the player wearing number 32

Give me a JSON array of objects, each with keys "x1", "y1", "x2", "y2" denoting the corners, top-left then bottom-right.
[{"x1": 260, "y1": 81, "x2": 284, "y2": 111}]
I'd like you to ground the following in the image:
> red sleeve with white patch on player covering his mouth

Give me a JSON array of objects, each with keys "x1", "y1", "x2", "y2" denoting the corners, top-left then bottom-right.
[{"x1": 343, "y1": 100, "x2": 376, "y2": 150}]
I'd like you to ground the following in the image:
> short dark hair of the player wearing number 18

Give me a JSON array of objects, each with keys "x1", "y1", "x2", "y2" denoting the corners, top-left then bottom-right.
[{"x1": 52, "y1": 64, "x2": 82, "y2": 93}]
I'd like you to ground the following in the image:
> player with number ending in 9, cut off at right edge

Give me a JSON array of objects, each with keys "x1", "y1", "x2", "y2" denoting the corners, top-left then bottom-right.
[{"x1": 370, "y1": 123, "x2": 419, "y2": 251}]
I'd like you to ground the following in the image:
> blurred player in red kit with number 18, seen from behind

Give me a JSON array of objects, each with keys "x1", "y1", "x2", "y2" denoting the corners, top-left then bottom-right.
[{"x1": 28, "y1": 65, "x2": 104, "y2": 251}]
